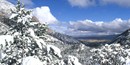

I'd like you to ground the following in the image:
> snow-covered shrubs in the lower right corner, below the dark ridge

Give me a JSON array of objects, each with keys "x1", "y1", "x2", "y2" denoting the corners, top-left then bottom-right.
[{"x1": 91, "y1": 44, "x2": 130, "y2": 65}]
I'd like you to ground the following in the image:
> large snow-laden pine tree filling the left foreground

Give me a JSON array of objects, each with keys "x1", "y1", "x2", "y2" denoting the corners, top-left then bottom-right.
[{"x1": 0, "y1": 0, "x2": 81, "y2": 65}]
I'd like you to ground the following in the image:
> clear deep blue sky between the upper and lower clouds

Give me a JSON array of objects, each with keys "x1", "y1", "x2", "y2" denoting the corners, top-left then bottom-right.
[{"x1": 9, "y1": 0, "x2": 130, "y2": 22}]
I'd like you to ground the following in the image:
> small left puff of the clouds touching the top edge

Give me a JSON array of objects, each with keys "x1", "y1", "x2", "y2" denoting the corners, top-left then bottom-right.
[{"x1": 68, "y1": 0, "x2": 95, "y2": 7}]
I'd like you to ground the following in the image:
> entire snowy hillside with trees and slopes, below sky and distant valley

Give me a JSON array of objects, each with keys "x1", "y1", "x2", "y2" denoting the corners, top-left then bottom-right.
[{"x1": 0, "y1": 0, "x2": 130, "y2": 65}]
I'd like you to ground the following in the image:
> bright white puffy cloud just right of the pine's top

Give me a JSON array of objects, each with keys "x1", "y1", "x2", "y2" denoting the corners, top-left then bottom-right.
[{"x1": 33, "y1": 6, "x2": 57, "y2": 24}]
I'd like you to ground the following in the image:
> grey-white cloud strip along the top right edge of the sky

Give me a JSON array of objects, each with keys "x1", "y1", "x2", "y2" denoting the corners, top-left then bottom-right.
[{"x1": 68, "y1": 0, "x2": 130, "y2": 7}]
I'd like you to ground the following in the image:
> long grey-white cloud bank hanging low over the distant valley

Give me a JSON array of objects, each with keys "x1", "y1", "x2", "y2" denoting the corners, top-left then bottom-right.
[{"x1": 70, "y1": 18, "x2": 130, "y2": 35}]
